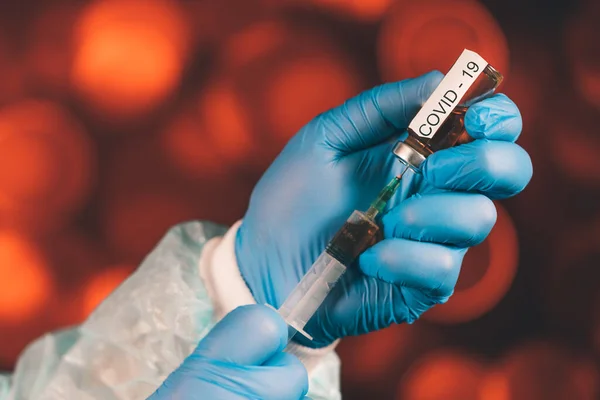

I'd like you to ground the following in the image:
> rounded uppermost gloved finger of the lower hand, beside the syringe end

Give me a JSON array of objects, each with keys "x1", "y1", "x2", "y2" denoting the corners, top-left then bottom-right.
[{"x1": 193, "y1": 305, "x2": 288, "y2": 365}]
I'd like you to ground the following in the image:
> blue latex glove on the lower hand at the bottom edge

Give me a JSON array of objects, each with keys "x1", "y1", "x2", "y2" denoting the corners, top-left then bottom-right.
[{"x1": 148, "y1": 305, "x2": 308, "y2": 400}]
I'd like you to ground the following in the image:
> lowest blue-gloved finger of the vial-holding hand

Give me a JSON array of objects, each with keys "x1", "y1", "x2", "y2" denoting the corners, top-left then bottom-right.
[{"x1": 358, "y1": 239, "x2": 466, "y2": 296}]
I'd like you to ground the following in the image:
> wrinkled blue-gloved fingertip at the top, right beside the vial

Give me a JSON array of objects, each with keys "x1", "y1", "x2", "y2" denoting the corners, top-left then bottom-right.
[{"x1": 465, "y1": 93, "x2": 523, "y2": 142}]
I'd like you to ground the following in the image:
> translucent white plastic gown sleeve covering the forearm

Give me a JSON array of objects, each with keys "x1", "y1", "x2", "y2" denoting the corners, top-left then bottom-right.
[{"x1": 0, "y1": 222, "x2": 341, "y2": 400}]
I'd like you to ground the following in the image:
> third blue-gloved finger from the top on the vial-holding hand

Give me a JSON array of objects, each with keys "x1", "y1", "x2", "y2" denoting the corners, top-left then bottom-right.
[{"x1": 382, "y1": 192, "x2": 496, "y2": 247}]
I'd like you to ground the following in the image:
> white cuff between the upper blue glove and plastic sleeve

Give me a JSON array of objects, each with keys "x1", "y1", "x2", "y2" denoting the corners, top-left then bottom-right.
[{"x1": 199, "y1": 221, "x2": 339, "y2": 374}]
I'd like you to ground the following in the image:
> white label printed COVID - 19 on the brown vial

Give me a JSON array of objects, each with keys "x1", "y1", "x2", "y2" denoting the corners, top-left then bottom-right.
[{"x1": 408, "y1": 49, "x2": 488, "y2": 138}]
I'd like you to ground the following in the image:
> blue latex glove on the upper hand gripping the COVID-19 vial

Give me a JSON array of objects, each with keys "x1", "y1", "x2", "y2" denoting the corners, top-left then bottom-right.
[{"x1": 236, "y1": 72, "x2": 532, "y2": 347}]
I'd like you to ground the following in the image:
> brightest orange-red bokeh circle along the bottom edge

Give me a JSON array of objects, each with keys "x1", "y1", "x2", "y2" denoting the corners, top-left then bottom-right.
[{"x1": 397, "y1": 349, "x2": 485, "y2": 400}]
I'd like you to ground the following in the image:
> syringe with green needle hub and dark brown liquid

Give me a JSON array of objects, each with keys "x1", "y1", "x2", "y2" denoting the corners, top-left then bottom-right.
[{"x1": 278, "y1": 167, "x2": 408, "y2": 340}]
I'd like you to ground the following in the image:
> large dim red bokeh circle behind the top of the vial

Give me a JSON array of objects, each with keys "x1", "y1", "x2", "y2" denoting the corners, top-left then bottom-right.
[{"x1": 378, "y1": 0, "x2": 509, "y2": 81}]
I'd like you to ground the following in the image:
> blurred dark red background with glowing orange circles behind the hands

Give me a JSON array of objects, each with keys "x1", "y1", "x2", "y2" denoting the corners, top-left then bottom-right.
[{"x1": 0, "y1": 0, "x2": 600, "y2": 400}]
